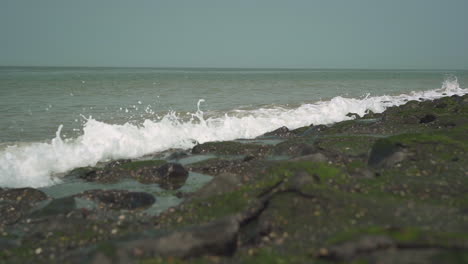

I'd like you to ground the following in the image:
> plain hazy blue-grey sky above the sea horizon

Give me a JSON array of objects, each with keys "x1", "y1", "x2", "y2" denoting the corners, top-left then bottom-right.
[{"x1": 0, "y1": 0, "x2": 468, "y2": 69}]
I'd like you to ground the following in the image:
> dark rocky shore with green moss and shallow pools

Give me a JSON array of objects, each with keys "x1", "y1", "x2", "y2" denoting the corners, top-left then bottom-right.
[{"x1": 0, "y1": 95, "x2": 468, "y2": 264}]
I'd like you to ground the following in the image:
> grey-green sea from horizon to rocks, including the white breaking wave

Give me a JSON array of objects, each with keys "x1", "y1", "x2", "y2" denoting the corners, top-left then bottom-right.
[{"x1": 0, "y1": 67, "x2": 468, "y2": 187}]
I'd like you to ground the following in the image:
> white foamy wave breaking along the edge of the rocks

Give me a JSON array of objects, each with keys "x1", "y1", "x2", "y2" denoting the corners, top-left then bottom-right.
[{"x1": 0, "y1": 80, "x2": 468, "y2": 187}]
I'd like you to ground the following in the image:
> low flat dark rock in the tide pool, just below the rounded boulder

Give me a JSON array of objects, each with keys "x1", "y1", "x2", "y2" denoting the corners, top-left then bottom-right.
[{"x1": 77, "y1": 190, "x2": 156, "y2": 210}]
